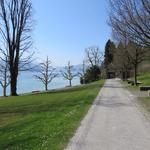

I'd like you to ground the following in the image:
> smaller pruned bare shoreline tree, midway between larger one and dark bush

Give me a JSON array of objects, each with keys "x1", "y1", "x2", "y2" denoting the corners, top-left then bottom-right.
[{"x1": 61, "y1": 61, "x2": 77, "y2": 87}]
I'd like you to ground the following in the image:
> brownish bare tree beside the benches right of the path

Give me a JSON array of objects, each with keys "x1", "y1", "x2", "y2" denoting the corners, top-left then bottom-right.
[{"x1": 113, "y1": 41, "x2": 147, "y2": 85}]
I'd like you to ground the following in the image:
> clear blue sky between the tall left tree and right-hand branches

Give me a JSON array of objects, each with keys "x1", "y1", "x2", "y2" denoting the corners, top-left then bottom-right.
[{"x1": 32, "y1": 0, "x2": 111, "y2": 66}]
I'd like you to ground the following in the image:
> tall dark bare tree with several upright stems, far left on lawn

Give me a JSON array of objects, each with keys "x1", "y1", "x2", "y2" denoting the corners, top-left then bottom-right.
[{"x1": 0, "y1": 0, "x2": 33, "y2": 96}]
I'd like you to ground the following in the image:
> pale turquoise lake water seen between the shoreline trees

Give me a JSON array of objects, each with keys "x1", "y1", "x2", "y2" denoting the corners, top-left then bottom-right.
[{"x1": 0, "y1": 72, "x2": 80, "y2": 95}]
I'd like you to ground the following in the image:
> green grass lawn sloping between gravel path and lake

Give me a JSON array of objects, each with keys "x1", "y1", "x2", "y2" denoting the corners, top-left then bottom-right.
[{"x1": 0, "y1": 81, "x2": 104, "y2": 150}]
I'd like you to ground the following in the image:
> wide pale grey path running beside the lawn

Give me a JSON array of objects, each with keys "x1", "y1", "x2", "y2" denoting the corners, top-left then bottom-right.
[{"x1": 66, "y1": 79, "x2": 150, "y2": 150}]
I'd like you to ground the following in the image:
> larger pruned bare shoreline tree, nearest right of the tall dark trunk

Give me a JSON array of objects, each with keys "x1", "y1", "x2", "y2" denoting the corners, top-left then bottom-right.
[{"x1": 35, "y1": 57, "x2": 58, "y2": 91}]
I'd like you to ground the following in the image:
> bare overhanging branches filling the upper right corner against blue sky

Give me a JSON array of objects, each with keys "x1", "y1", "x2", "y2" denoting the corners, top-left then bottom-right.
[{"x1": 109, "y1": 0, "x2": 150, "y2": 47}]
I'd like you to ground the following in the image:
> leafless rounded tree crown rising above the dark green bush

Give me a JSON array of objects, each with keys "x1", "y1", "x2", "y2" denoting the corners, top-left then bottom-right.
[{"x1": 85, "y1": 46, "x2": 103, "y2": 67}]
